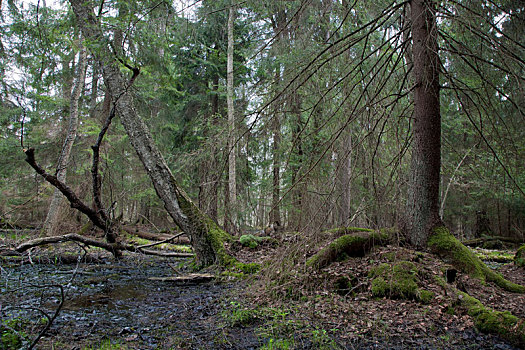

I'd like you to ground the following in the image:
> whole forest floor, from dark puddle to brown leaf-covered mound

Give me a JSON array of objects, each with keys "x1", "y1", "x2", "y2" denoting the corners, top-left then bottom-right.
[{"x1": 0, "y1": 228, "x2": 525, "y2": 349}]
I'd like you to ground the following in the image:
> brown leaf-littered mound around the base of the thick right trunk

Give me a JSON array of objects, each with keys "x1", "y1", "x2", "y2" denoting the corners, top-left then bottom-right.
[{"x1": 233, "y1": 228, "x2": 525, "y2": 348}]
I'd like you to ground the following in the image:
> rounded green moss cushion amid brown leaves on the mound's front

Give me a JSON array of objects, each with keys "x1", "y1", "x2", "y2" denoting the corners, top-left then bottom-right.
[{"x1": 368, "y1": 261, "x2": 434, "y2": 303}]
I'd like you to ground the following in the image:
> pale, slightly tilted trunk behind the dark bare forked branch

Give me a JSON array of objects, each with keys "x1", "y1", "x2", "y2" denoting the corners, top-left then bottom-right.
[{"x1": 43, "y1": 48, "x2": 87, "y2": 236}]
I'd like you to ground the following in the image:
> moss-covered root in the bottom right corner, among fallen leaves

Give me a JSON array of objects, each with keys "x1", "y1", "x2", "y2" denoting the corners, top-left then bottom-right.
[{"x1": 459, "y1": 292, "x2": 525, "y2": 347}]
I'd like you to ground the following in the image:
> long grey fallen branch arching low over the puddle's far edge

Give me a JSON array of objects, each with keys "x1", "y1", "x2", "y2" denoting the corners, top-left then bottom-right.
[{"x1": 15, "y1": 233, "x2": 194, "y2": 257}]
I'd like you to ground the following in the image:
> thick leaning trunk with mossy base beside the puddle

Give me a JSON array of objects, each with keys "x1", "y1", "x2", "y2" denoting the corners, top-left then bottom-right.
[{"x1": 70, "y1": 0, "x2": 231, "y2": 266}]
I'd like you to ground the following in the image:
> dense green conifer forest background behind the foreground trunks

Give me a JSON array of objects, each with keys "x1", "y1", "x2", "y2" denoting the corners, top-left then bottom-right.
[{"x1": 0, "y1": 0, "x2": 525, "y2": 238}]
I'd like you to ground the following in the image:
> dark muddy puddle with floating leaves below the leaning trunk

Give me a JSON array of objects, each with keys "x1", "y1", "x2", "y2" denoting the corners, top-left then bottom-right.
[{"x1": 0, "y1": 258, "x2": 261, "y2": 349}]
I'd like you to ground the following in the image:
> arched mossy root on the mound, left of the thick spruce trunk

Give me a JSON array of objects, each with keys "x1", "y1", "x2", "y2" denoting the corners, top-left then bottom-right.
[{"x1": 306, "y1": 229, "x2": 390, "y2": 269}]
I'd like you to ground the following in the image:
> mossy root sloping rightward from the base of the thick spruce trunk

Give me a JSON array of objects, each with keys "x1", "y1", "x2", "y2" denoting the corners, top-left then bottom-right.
[{"x1": 428, "y1": 227, "x2": 525, "y2": 293}]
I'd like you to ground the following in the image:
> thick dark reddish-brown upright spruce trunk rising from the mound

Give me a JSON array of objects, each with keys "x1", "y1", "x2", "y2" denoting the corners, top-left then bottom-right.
[{"x1": 406, "y1": 0, "x2": 441, "y2": 247}]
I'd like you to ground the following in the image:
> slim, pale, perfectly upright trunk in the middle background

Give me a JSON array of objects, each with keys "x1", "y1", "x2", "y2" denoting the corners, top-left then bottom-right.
[{"x1": 224, "y1": 5, "x2": 237, "y2": 233}]
